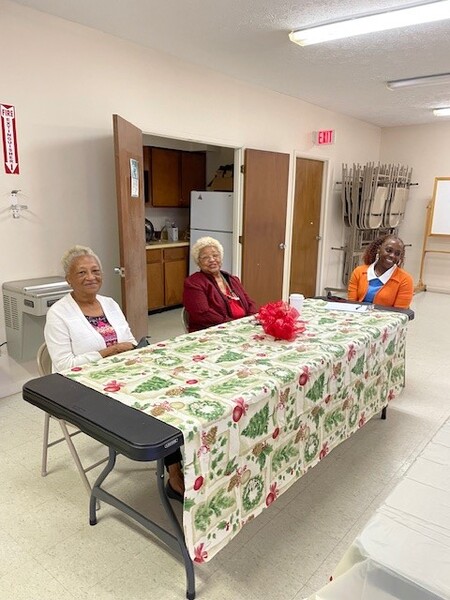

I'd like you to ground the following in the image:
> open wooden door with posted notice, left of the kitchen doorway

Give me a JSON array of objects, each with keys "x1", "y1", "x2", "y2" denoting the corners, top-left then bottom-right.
[{"x1": 113, "y1": 115, "x2": 148, "y2": 339}]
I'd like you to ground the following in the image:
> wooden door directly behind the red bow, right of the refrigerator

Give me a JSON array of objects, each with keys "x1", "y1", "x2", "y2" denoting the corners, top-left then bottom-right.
[{"x1": 242, "y1": 149, "x2": 289, "y2": 305}]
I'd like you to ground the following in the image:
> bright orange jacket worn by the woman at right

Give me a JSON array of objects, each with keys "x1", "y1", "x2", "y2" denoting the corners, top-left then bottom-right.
[{"x1": 348, "y1": 265, "x2": 414, "y2": 308}]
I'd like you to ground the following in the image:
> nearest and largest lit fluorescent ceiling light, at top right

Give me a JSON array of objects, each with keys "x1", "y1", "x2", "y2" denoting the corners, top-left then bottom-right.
[{"x1": 289, "y1": 0, "x2": 450, "y2": 46}]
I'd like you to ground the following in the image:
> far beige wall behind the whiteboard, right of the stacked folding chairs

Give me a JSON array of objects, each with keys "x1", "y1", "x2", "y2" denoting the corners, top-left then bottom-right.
[{"x1": 381, "y1": 119, "x2": 450, "y2": 292}]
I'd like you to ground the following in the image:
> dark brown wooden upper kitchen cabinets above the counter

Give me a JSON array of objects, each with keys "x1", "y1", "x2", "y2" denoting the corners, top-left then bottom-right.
[{"x1": 144, "y1": 147, "x2": 206, "y2": 207}]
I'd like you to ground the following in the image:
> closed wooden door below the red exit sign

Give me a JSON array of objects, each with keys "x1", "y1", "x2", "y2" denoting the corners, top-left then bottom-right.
[{"x1": 289, "y1": 158, "x2": 323, "y2": 297}]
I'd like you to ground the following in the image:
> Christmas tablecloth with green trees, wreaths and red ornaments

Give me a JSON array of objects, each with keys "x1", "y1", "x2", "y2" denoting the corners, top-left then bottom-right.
[{"x1": 63, "y1": 300, "x2": 408, "y2": 563}]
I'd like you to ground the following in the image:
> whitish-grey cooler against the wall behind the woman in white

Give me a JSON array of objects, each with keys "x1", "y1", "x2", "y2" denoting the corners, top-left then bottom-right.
[{"x1": 2, "y1": 275, "x2": 72, "y2": 361}]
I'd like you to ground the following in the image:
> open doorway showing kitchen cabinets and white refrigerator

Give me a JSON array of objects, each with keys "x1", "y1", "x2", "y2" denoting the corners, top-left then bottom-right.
[{"x1": 142, "y1": 134, "x2": 237, "y2": 314}]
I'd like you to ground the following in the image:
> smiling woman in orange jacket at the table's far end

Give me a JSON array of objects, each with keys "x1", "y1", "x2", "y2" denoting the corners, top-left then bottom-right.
[{"x1": 348, "y1": 235, "x2": 414, "y2": 308}]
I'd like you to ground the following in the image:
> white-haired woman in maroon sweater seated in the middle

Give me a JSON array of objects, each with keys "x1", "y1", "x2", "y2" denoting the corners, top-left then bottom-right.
[{"x1": 183, "y1": 237, "x2": 257, "y2": 331}]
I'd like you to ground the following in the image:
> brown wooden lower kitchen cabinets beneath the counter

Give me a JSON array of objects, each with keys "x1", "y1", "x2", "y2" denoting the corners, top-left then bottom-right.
[{"x1": 147, "y1": 246, "x2": 189, "y2": 310}]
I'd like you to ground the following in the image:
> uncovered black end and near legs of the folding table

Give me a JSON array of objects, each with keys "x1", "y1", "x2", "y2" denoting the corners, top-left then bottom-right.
[{"x1": 22, "y1": 373, "x2": 195, "y2": 600}]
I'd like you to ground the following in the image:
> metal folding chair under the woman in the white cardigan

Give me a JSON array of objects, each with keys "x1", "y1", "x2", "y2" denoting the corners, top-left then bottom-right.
[{"x1": 37, "y1": 342, "x2": 108, "y2": 495}]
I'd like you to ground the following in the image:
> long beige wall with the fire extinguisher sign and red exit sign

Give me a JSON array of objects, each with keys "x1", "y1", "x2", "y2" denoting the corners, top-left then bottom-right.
[{"x1": 0, "y1": 0, "x2": 384, "y2": 341}]
